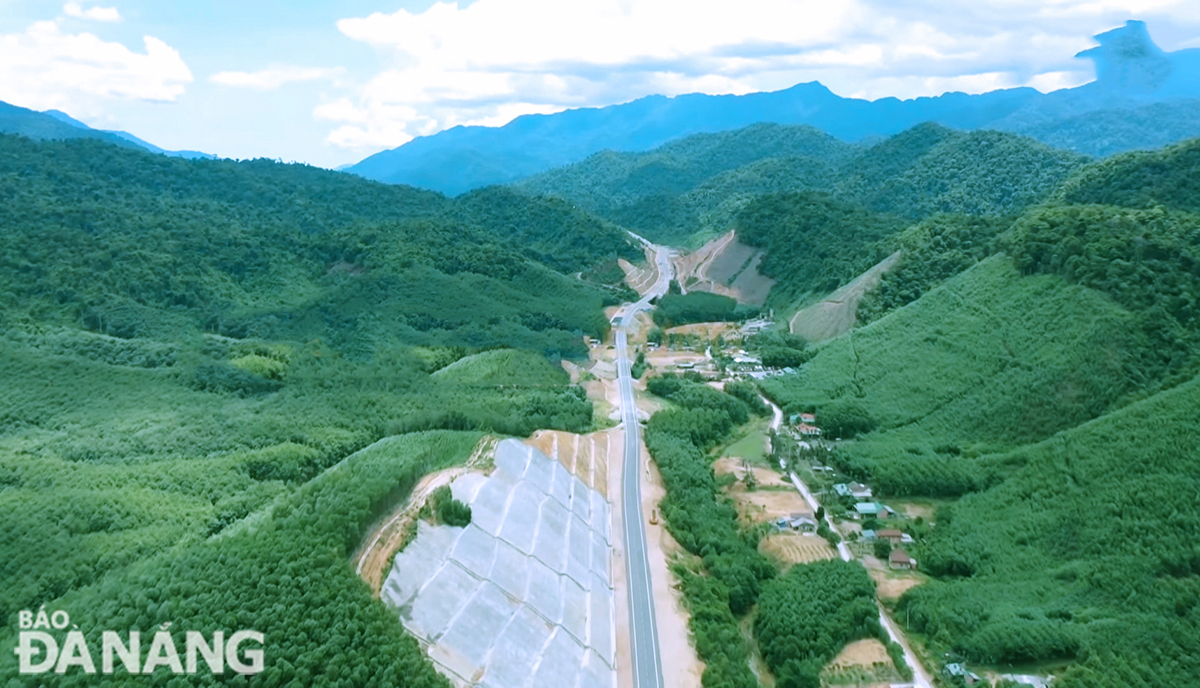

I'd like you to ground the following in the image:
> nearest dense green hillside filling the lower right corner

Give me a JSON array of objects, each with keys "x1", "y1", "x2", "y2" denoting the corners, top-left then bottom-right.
[{"x1": 900, "y1": 379, "x2": 1200, "y2": 688}]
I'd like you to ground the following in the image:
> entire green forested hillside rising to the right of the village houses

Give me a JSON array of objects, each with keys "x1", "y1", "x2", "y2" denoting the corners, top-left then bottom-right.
[{"x1": 764, "y1": 135, "x2": 1200, "y2": 688}]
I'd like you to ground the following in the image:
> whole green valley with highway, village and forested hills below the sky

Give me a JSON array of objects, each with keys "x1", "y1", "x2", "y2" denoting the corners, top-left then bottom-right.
[{"x1": 0, "y1": 20, "x2": 1200, "y2": 688}]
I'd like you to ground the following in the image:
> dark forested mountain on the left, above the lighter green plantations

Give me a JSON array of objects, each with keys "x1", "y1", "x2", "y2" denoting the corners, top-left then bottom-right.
[{"x1": 0, "y1": 132, "x2": 638, "y2": 353}]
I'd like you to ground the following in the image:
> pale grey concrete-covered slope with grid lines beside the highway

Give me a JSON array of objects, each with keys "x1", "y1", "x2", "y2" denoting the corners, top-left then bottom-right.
[{"x1": 382, "y1": 439, "x2": 617, "y2": 688}]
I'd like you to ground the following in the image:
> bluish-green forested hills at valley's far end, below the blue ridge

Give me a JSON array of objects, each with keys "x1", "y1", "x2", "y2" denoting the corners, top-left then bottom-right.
[{"x1": 514, "y1": 124, "x2": 1087, "y2": 249}]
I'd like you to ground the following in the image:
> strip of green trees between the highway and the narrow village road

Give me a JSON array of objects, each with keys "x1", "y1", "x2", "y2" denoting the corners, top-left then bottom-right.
[{"x1": 646, "y1": 376, "x2": 905, "y2": 688}]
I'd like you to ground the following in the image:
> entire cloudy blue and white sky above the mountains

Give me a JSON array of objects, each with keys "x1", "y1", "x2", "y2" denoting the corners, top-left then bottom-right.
[{"x1": 0, "y1": 0, "x2": 1200, "y2": 167}]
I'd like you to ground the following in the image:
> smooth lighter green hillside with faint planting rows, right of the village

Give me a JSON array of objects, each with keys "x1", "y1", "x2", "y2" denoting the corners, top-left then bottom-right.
[{"x1": 764, "y1": 257, "x2": 1145, "y2": 456}]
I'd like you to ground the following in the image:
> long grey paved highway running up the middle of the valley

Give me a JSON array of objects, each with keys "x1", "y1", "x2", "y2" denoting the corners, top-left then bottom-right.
[{"x1": 617, "y1": 238, "x2": 672, "y2": 688}]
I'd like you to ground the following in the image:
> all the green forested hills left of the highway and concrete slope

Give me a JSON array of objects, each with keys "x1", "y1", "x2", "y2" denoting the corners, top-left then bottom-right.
[{"x1": 0, "y1": 130, "x2": 641, "y2": 687}]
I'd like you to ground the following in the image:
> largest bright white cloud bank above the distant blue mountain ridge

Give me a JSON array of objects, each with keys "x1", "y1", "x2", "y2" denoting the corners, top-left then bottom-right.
[{"x1": 324, "y1": 0, "x2": 1200, "y2": 146}]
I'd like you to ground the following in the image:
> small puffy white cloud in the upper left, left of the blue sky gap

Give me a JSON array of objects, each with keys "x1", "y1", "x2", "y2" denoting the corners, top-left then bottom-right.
[{"x1": 0, "y1": 22, "x2": 192, "y2": 115}]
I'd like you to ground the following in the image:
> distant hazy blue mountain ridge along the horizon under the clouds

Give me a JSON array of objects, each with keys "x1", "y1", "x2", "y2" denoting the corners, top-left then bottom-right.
[{"x1": 347, "y1": 22, "x2": 1200, "y2": 195}]
